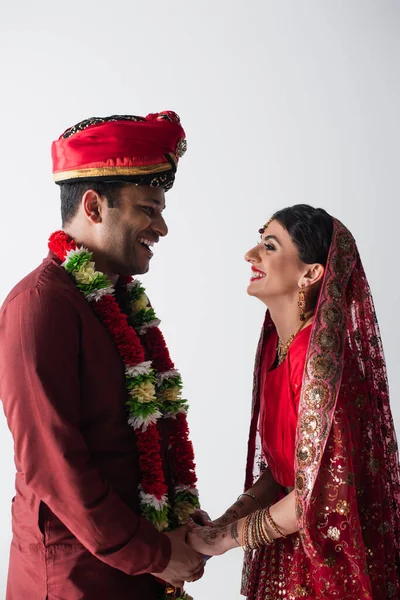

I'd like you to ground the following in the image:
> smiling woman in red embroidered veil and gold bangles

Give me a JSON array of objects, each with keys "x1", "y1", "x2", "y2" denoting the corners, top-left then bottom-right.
[{"x1": 189, "y1": 205, "x2": 400, "y2": 600}]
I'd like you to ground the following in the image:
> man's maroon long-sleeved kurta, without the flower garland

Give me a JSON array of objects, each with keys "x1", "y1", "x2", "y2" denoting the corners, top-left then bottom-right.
[{"x1": 0, "y1": 254, "x2": 171, "y2": 600}]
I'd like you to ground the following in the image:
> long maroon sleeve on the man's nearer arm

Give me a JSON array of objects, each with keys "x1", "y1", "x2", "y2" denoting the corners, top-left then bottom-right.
[{"x1": 0, "y1": 288, "x2": 171, "y2": 575}]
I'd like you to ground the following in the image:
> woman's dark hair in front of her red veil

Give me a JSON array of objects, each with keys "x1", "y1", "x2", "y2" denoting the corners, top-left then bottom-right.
[{"x1": 272, "y1": 204, "x2": 333, "y2": 266}]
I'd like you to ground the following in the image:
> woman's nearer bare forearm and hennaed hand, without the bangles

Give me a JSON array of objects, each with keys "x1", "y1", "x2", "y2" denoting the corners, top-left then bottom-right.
[{"x1": 188, "y1": 491, "x2": 298, "y2": 556}]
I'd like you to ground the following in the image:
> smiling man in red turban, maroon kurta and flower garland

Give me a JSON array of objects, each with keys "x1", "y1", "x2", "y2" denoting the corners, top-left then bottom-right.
[{"x1": 0, "y1": 112, "x2": 203, "y2": 600}]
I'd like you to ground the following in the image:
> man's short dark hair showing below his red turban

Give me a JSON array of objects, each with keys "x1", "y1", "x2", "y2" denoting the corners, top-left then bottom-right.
[{"x1": 60, "y1": 181, "x2": 126, "y2": 227}]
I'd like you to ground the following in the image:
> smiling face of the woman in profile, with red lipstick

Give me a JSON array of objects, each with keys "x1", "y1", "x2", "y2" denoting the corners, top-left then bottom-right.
[{"x1": 245, "y1": 220, "x2": 310, "y2": 305}]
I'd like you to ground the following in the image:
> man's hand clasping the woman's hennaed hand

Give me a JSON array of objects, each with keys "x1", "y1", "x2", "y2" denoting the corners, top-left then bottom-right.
[{"x1": 152, "y1": 525, "x2": 204, "y2": 588}]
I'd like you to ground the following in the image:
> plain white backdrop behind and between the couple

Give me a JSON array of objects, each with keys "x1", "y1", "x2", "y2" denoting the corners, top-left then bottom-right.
[{"x1": 0, "y1": 0, "x2": 400, "y2": 600}]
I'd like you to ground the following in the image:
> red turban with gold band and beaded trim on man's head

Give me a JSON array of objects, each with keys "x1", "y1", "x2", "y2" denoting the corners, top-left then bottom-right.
[{"x1": 51, "y1": 111, "x2": 187, "y2": 190}]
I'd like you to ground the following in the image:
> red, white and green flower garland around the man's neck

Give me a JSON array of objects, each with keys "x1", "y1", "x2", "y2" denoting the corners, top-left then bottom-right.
[{"x1": 49, "y1": 231, "x2": 199, "y2": 600}]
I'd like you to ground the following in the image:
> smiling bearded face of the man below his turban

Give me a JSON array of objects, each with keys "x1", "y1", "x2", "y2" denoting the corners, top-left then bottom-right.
[{"x1": 96, "y1": 184, "x2": 168, "y2": 275}]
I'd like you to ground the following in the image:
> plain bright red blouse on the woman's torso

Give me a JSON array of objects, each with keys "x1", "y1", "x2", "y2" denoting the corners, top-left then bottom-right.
[{"x1": 259, "y1": 326, "x2": 311, "y2": 487}]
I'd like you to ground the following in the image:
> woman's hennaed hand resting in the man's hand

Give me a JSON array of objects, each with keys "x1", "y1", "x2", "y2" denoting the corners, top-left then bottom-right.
[{"x1": 187, "y1": 522, "x2": 241, "y2": 556}]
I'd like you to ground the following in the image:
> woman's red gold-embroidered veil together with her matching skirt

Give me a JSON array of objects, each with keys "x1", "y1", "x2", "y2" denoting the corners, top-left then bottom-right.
[{"x1": 242, "y1": 220, "x2": 400, "y2": 600}]
